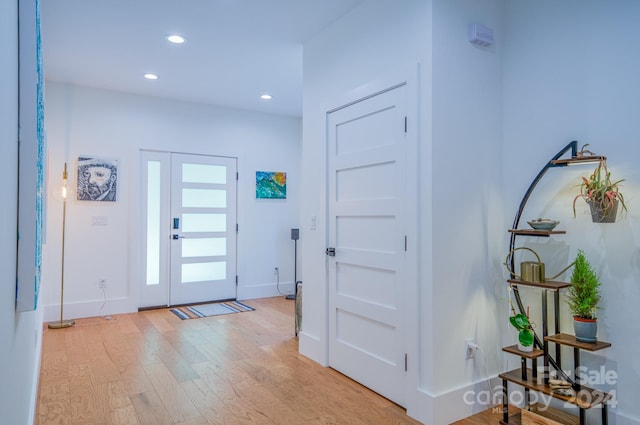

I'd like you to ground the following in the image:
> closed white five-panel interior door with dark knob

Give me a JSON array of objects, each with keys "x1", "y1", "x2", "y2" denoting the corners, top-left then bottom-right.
[{"x1": 327, "y1": 85, "x2": 407, "y2": 405}]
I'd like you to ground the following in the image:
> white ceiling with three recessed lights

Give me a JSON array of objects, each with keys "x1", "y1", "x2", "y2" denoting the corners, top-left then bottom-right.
[{"x1": 40, "y1": 0, "x2": 364, "y2": 116}]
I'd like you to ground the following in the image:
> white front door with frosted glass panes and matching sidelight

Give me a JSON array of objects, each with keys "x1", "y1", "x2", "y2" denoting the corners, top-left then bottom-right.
[{"x1": 139, "y1": 152, "x2": 237, "y2": 307}]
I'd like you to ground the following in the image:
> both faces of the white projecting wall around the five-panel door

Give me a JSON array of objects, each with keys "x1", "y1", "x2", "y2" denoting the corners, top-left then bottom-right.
[{"x1": 300, "y1": 0, "x2": 506, "y2": 424}]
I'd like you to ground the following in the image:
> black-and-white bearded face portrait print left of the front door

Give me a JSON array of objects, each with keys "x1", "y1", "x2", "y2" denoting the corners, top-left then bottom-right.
[{"x1": 78, "y1": 157, "x2": 118, "y2": 201}]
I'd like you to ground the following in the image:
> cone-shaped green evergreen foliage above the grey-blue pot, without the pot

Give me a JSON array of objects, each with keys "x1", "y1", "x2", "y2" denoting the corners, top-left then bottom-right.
[{"x1": 567, "y1": 250, "x2": 601, "y2": 319}]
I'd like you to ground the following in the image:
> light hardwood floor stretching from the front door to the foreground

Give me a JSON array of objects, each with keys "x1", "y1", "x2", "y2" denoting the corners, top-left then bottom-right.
[{"x1": 35, "y1": 297, "x2": 418, "y2": 425}]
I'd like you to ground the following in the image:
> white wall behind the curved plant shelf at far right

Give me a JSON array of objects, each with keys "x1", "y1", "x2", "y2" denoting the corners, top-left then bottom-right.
[{"x1": 503, "y1": 0, "x2": 640, "y2": 424}]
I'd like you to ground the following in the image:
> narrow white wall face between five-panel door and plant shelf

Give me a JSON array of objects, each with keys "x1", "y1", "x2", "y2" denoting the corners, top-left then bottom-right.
[{"x1": 425, "y1": 0, "x2": 507, "y2": 423}]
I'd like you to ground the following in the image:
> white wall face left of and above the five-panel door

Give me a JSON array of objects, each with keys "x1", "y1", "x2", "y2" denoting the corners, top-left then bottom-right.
[{"x1": 300, "y1": 1, "x2": 429, "y2": 358}]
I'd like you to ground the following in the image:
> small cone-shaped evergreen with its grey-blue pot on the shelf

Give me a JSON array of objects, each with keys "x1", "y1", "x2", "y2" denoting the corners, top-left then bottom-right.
[{"x1": 567, "y1": 250, "x2": 601, "y2": 342}]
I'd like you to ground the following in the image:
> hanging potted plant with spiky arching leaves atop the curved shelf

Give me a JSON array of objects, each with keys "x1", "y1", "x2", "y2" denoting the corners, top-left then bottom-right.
[{"x1": 573, "y1": 159, "x2": 627, "y2": 223}]
